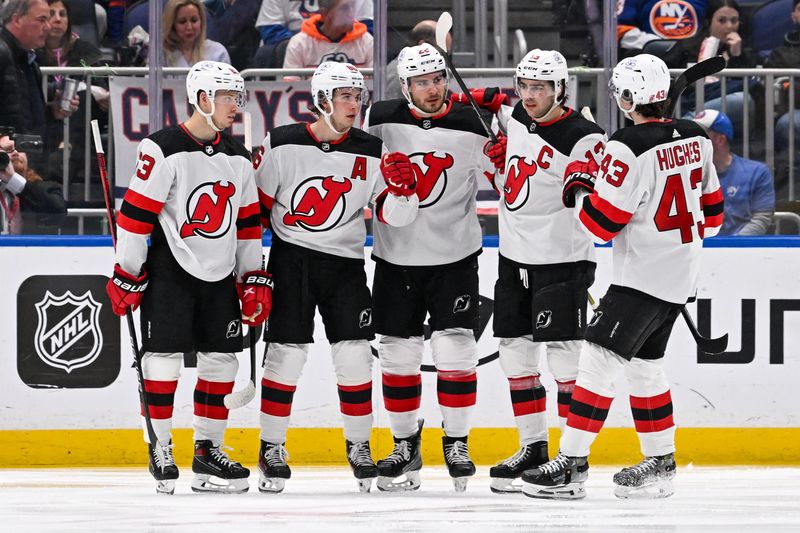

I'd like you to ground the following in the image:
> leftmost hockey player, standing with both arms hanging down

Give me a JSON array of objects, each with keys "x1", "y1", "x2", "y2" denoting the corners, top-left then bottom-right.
[{"x1": 107, "y1": 61, "x2": 271, "y2": 494}]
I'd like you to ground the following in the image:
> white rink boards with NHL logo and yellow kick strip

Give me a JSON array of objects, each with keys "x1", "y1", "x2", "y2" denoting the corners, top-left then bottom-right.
[{"x1": 0, "y1": 237, "x2": 800, "y2": 466}]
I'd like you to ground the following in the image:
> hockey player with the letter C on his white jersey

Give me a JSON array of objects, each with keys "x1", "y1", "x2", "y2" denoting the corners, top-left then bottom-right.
[{"x1": 488, "y1": 49, "x2": 606, "y2": 492}]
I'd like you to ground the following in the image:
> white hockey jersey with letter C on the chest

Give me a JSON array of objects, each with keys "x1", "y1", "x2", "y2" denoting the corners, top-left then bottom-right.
[{"x1": 495, "y1": 101, "x2": 606, "y2": 266}]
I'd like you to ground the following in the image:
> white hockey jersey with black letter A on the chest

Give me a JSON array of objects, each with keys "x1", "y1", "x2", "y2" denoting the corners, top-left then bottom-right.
[{"x1": 255, "y1": 124, "x2": 416, "y2": 259}]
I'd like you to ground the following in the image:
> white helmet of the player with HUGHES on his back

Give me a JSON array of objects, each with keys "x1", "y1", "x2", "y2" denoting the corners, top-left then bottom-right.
[{"x1": 608, "y1": 54, "x2": 670, "y2": 118}]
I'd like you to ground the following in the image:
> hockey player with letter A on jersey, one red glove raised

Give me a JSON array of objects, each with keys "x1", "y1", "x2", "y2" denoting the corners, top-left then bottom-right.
[{"x1": 255, "y1": 62, "x2": 418, "y2": 492}]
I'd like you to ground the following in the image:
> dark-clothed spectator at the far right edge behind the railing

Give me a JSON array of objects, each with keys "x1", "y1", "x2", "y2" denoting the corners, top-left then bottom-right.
[{"x1": 764, "y1": 0, "x2": 800, "y2": 154}]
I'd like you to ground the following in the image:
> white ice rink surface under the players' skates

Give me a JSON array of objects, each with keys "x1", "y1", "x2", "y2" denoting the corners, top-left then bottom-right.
[{"x1": 0, "y1": 467, "x2": 800, "y2": 533}]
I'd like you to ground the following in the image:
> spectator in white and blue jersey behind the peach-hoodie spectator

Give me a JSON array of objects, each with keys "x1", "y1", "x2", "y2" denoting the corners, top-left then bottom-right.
[{"x1": 253, "y1": 0, "x2": 372, "y2": 68}]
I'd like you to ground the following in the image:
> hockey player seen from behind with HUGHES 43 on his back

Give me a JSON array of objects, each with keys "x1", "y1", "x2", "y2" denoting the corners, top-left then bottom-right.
[{"x1": 522, "y1": 54, "x2": 723, "y2": 499}]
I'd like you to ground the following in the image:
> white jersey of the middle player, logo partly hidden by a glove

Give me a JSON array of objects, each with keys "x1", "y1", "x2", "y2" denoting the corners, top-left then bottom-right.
[{"x1": 364, "y1": 99, "x2": 494, "y2": 266}]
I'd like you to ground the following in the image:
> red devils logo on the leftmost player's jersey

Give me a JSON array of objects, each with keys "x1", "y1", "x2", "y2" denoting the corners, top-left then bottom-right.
[{"x1": 181, "y1": 181, "x2": 236, "y2": 239}]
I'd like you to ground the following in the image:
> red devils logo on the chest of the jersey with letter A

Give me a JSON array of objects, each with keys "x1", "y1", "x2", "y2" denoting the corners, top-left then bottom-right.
[{"x1": 283, "y1": 176, "x2": 353, "y2": 231}]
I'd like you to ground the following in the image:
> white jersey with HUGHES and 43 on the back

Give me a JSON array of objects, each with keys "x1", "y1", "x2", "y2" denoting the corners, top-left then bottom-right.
[{"x1": 578, "y1": 120, "x2": 723, "y2": 304}]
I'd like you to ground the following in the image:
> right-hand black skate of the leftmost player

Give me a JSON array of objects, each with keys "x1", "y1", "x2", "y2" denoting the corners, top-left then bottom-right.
[{"x1": 192, "y1": 440, "x2": 250, "y2": 494}]
